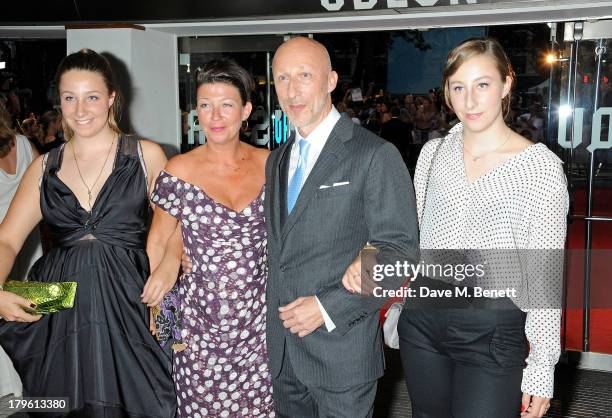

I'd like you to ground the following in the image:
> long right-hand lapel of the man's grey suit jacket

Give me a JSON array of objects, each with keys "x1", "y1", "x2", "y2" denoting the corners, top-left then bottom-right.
[{"x1": 281, "y1": 117, "x2": 354, "y2": 241}]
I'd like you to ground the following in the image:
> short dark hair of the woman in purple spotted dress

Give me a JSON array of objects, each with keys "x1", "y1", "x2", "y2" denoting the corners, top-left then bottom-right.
[{"x1": 196, "y1": 59, "x2": 255, "y2": 106}]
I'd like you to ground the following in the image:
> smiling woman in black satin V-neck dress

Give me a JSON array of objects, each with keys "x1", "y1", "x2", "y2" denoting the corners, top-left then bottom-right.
[{"x1": 0, "y1": 50, "x2": 176, "y2": 418}]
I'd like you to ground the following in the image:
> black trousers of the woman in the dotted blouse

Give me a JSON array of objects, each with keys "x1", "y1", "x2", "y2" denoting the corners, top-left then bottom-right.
[{"x1": 398, "y1": 299, "x2": 528, "y2": 418}]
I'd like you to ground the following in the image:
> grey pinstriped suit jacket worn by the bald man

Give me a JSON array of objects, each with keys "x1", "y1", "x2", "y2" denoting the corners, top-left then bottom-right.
[{"x1": 265, "y1": 116, "x2": 418, "y2": 388}]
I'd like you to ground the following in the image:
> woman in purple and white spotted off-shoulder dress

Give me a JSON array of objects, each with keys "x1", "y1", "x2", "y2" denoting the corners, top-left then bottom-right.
[{"x1": 143, "y1": 61, "x2": 274, "y2": 418}]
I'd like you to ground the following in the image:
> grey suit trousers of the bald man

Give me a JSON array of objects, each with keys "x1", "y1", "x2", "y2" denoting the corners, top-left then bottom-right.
[{"x1": 272, "y1": 353, "x2": 377, "y2": 418}]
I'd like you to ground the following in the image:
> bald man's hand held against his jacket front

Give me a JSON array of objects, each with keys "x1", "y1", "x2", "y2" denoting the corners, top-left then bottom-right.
[{"x1": 278, "y1": 296, "x2": 325, "y2": 337}]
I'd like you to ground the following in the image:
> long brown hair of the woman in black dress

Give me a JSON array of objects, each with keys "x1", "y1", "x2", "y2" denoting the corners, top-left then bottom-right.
[{"x1": 55, "y1": 48, "x2": 121, "y2": 140}]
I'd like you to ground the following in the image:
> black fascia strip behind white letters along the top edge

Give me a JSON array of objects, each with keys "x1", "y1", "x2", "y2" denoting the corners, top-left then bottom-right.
[{"x1": 0, "y1": 0, "x2": 520, "y2": 26}]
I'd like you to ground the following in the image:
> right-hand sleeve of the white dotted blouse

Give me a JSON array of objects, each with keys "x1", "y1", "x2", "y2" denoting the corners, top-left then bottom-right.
[{"x1": 521, "y1": 168, "x2": 569, "y2": 398}]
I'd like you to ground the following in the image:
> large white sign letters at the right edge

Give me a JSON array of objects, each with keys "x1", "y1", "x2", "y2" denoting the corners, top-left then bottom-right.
[{"x1": 557, "y1": 107, "x2": 612, "y2": 152}]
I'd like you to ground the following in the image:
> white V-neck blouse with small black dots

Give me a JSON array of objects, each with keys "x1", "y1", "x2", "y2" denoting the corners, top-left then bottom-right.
[{"x1": 414, "y1": 124, "x2": 569, "y2": 398}]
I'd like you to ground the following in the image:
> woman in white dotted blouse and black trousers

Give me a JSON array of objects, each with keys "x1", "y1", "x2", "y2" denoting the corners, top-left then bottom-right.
[{"x1": 398, "y1": 39, "x2": 568, "y2": 418}]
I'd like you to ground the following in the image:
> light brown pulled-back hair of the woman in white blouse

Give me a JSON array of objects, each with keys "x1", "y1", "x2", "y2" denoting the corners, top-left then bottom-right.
[{"x1": 442, "y1": 38, "x2": 516, "y2": 115}]
